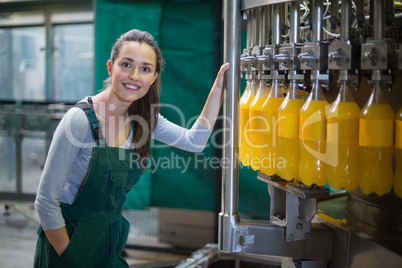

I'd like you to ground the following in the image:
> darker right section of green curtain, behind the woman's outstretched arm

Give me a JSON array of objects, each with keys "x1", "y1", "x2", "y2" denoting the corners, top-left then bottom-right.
[{"x1": 152, "y1": 1, "x2": 217, "y2": 210}]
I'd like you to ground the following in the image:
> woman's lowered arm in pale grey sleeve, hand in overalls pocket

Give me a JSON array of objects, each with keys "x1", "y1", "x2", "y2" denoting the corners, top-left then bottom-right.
[{"x1": 35, "y1": 108, "x2": 91, "y2": 255}]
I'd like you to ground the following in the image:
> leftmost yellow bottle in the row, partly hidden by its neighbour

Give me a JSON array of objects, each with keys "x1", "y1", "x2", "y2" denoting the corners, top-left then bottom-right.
[{"x1": 239, "y1": 81, "x2": 255, "y2": 166}]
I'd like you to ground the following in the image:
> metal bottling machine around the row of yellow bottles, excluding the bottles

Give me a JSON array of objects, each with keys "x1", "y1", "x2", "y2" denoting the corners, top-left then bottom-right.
[{"x1": 218, "y1": 0, "x2": 402, "y2": 267}]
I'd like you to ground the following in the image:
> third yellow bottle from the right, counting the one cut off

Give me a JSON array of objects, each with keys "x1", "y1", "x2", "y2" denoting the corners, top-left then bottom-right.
[{"x1": 327, "y1": 81, "x2": 361, "y2": 191}]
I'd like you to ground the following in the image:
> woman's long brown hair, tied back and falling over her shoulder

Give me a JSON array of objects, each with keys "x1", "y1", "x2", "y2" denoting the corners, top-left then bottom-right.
[{"x1": 104, "y1": 30, "x2": 164, "y2": 163}]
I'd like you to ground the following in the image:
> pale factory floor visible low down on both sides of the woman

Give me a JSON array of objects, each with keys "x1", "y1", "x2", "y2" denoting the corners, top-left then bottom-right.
[{"x1": 0, "y1": 201, "x2": 280, "y2": 268}]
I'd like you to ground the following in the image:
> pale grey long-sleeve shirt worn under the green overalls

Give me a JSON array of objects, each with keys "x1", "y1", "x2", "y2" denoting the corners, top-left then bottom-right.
[{"x1": 35, "y1": 98, "x2": 211, "y2": 230}]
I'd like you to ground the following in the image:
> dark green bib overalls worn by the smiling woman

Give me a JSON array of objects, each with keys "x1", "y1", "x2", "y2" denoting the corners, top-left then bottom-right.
[{"x1": 34, "y1": 99, "x2": 143, "y2": 268}]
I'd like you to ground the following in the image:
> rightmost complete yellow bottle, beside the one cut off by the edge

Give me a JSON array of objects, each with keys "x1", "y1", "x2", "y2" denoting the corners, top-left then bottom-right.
[{"x1": 359, "y1": 81, "x2": 395, "y2": 196}]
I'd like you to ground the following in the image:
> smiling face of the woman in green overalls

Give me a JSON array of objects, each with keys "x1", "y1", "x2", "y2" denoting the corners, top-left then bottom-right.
[{"x1": 107, "y1": 41, "x2": 158, "y2": 103}]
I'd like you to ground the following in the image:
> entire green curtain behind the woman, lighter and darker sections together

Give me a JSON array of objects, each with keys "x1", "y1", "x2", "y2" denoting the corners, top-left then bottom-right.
[{"x1": 95, "y1": 0, "x2": 269, "y2": 218}]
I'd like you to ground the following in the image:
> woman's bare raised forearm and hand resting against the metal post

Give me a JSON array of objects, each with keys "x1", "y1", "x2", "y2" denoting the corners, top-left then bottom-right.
[{"x1": 198, "y1": 63, "x2": 230, "y2": 130}]
